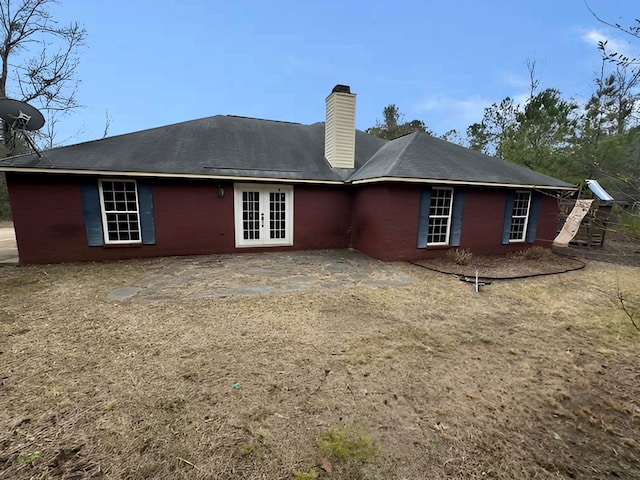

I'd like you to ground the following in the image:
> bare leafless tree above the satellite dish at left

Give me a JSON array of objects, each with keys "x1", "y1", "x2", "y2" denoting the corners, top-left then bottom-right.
[{"x1": 0, "y1": 0, "x2": 86, "y2": 150}]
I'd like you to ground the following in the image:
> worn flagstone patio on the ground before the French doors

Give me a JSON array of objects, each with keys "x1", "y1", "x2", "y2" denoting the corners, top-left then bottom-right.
[{"x1": 109, "y1": 250, "x2": 415, "y2": 301}]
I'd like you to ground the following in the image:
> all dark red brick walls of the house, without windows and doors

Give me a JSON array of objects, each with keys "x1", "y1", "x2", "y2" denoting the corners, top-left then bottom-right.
[{"x1": 7, "y1": 172, "x2": 558, "y2": 264}]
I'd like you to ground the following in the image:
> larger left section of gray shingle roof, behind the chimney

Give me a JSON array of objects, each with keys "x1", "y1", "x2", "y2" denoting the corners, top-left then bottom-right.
[{"x1": 0, "y1": 115, "x2": 384, "y2": 182}]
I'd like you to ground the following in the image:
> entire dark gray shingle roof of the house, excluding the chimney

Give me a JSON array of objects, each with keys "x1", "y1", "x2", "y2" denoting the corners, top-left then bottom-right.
[{"x1": 0, "y1": 115, "x2": 571, "y2": 188}]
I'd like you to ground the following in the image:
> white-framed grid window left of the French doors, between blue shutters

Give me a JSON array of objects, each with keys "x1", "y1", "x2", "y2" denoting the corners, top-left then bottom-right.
[{"x1": 99, "y1": 179, "x2": 142, "y2": 244}]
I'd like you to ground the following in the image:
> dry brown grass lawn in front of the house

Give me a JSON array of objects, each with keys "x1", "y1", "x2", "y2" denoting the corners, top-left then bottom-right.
[{"x1": 0, "y1": 253, "x2": 640, "y2": 480}]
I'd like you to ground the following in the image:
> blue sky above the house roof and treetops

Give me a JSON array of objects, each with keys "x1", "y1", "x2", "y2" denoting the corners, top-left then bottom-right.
[{"x1": 33, "y1": 0, "x2": 640, "y2": 144}]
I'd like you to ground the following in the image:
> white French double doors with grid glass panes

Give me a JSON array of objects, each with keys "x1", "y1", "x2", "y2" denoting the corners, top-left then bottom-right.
[{"x1": 234, "y1": 184, "x2": 293, "y2": 247}]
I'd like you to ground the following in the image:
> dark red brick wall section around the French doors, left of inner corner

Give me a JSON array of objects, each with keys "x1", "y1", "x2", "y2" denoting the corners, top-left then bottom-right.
[{"x1": 7, "y1": 173, "x2": 351, "y2": 264}]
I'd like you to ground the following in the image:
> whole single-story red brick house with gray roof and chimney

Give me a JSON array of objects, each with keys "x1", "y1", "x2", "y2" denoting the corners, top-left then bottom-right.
[{"x1": 0, "y1": 86, "x2": 575, "y2": 264}]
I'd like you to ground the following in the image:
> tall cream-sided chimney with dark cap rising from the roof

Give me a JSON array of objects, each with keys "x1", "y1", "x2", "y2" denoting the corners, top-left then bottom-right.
[{"x1": 324, "y1": 85, "x2": 356, "y2": 168}]
